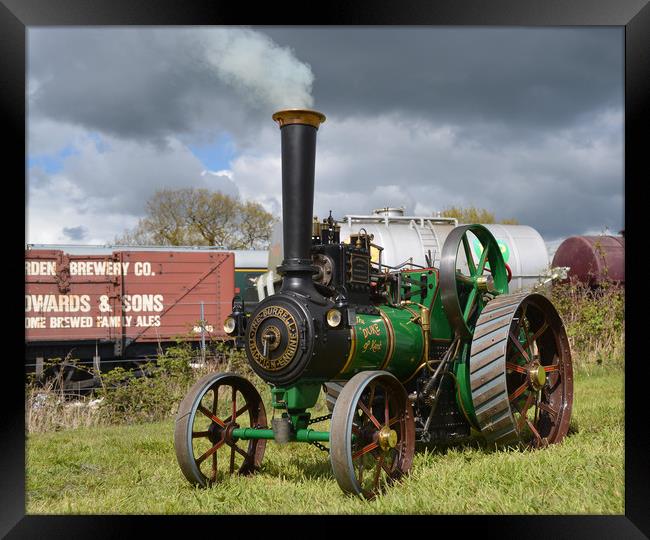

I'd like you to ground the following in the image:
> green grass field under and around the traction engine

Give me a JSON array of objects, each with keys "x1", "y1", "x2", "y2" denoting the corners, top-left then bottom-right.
[{"x1": 26, "y1": 367, "x2": 624, "y2": 514}]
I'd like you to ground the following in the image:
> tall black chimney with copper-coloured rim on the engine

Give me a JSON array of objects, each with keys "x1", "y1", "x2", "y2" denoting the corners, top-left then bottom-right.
[{"x1": 273, "y1": 109, "x2": 325, "y2": 301}]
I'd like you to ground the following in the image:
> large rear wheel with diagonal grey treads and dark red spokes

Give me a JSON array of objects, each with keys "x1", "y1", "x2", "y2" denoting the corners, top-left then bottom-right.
[{"x1": 469, "y1": 293, "x2": 573, "y2": 448}]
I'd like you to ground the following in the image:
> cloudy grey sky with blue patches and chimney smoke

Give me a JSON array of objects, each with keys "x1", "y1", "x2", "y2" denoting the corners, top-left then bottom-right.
[{"x1": 25, "y1": 26, "x2": 624, "y2": 251}]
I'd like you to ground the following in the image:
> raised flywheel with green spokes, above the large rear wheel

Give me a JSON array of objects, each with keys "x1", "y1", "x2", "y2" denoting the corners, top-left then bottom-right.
[{"x1": 440, "y1": 225, "x2": 508, "y2": 339}]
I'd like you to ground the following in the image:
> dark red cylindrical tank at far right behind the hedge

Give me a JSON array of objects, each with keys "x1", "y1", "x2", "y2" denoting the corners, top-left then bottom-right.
[{"x1": 553, "y1": 235, "x2": 625, "y2": 287}]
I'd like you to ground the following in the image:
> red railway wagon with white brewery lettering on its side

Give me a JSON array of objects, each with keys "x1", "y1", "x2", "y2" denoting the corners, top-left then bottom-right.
[{"x1": 25, "y1": 249, "x2": 235, "y2": 378}]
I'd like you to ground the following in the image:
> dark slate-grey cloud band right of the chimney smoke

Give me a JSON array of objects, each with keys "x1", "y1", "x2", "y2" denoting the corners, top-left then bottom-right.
[{"x1": 263, "y1": 27, "x2": 624, "y2": 136}]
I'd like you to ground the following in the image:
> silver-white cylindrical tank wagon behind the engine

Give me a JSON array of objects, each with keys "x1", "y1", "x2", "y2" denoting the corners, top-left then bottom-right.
[{"x1": 258, "y1": 208, "x2": 549, "y2": 298}]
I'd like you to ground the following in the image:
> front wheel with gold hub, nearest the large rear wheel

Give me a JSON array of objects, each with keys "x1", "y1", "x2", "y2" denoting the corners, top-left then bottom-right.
[{"x1": 330, "y1": 372, "x2": 415, "y2": 499}]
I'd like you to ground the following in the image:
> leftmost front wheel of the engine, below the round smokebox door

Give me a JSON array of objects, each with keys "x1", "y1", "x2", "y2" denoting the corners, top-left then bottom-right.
[{"x1": 174, "y1": 373, "x2": 267, "y2": 487}]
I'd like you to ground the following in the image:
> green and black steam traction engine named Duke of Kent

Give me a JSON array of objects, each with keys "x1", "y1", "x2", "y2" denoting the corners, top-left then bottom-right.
[{"x1": 174, "y1": 109, "x2": 573, "y2": 498}]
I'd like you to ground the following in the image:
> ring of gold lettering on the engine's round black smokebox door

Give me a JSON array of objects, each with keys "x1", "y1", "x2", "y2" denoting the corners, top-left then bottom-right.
[{"x1": 248, "y1": 306, "x2": 299, "y2": 371}]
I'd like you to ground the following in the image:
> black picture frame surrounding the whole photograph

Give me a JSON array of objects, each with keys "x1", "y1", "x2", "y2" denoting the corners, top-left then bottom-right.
[{"x1": 0, "y1": 0, "x2": 650, "y2": 539}]
